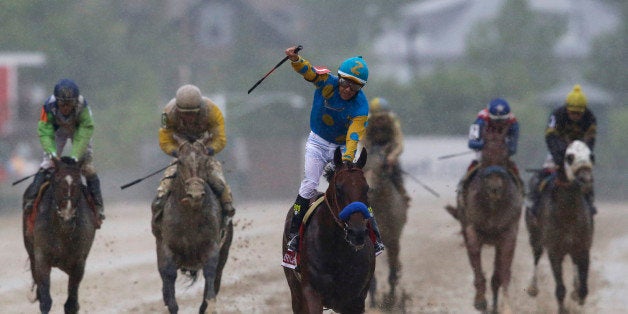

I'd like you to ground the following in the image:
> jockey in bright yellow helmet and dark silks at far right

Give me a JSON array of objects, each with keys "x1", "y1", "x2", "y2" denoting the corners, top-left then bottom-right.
[{"x1": 527, "y1": 84, "x2": 597, "y2": 217}]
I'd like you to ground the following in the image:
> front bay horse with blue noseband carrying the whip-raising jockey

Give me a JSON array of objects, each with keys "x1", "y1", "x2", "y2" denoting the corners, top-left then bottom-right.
[{"x1": 282, "y1": 148, "x2": 375, "y2": 313}]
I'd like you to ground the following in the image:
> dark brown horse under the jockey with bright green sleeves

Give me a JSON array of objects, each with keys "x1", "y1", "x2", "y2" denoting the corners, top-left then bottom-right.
[{"x1": 22, "y1": 157, "x2": 97, "y2": 313}]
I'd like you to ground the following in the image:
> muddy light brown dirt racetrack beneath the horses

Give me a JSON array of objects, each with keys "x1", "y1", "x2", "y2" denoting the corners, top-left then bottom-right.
[{"x1": 0, "y1": 187, "x2": 628, "y2": 313}]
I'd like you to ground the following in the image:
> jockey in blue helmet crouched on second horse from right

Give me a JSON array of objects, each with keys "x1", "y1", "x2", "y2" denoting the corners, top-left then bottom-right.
[{"x1": 457, "y1": 98, "x2": 523, "y2": 204}]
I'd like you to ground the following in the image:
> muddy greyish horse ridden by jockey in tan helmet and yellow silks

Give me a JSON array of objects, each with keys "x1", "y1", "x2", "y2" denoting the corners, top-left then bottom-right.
[{"x1": 153, "y1": 136, "x2": 233, "y2": 313}]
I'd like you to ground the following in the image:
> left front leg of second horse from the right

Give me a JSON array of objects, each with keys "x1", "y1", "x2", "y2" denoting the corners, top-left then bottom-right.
[{"x1": 463, "y1": 226, "x2": 487, "y2": 311}]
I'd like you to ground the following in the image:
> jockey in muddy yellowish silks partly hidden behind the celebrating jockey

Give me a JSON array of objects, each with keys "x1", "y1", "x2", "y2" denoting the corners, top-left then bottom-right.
[{"x1": 363, "y1": 97, "x2": 410, "y2": 204}]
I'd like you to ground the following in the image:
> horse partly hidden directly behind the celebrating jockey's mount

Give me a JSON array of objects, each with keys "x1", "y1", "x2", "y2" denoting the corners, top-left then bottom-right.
[{"x1": 364, "y1": 144, "x2": 408, "y2": 310}]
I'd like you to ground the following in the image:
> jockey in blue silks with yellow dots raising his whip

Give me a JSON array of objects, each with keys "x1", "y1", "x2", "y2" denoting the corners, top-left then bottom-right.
[{"x1": 282, "y1": 47, "x2": 384, "y2": 269}]
